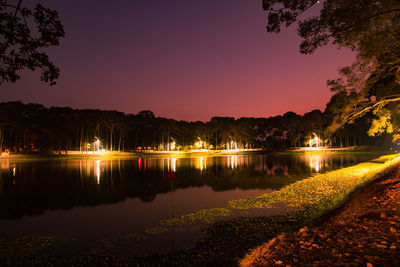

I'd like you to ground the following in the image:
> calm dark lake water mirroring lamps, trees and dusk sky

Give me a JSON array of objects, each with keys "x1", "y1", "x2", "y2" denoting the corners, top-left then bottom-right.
[{"x1": 0, "y1": 155, "x2": 376, "y2": 254}]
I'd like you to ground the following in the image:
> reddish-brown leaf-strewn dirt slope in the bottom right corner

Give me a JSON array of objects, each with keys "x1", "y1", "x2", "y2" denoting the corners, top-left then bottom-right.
[{"x1": 241, "y1": 165, "x2": 400, "y2": 266}]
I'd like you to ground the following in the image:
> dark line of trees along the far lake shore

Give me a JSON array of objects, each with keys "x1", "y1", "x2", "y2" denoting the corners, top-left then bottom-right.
[{"x1": 0, "y1": 101, "x2": 390, "y2": 153}]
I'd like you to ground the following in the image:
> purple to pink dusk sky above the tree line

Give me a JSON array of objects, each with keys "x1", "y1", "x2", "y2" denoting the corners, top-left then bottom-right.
[{"x1": 0, "y1": 0, "x2": 354, "y2": 121}]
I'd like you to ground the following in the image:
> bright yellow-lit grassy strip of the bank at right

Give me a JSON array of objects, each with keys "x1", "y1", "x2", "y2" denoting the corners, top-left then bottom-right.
[{"x1": 228, "y1": 155, "x2": 398, "y2": 221}]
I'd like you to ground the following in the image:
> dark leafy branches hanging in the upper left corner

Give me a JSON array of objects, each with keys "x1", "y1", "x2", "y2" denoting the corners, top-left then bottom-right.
[{"x1": 0, "y1": 0, "x2": 65, "y2": 85}]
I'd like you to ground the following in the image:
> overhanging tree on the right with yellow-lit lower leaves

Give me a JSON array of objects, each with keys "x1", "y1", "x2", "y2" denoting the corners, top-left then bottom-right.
[{"x1": 263, "y1": 0, "x2": 400, "y2": 140}]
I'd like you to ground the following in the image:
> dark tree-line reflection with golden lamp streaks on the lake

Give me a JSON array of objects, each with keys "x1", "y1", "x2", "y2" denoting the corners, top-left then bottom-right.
[{"x1": 0, "y1": 155, "x2": 371, "y2": 221}]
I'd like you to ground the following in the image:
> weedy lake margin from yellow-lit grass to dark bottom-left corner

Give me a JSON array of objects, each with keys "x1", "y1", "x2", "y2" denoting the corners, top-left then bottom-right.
[{"x1": 1, "y1": 154, "x2": 400, "y2": 265}]
